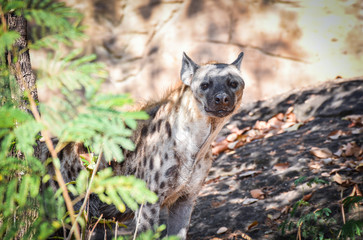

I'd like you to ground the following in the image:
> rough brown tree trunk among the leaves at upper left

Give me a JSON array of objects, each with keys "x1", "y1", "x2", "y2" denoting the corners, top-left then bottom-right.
[{"x1": 6, "y1": 13, "x2": 38, "y2": 107}]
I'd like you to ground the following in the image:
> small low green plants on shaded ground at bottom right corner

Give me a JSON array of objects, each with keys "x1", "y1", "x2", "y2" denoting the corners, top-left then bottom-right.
[{"x1": 279, "y1": 177, "x2": 363, "y2": 240}]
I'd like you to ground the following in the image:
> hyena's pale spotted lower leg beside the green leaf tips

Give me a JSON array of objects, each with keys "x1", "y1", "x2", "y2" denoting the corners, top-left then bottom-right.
[{"x1": 135, "y1": 203, "x2": 160, "y2": 233}]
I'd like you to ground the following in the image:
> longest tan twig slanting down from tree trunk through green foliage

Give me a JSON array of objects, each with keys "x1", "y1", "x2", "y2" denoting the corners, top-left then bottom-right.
[{"x1": 27, "y1": 77, "x2": 81, "y2": 240}]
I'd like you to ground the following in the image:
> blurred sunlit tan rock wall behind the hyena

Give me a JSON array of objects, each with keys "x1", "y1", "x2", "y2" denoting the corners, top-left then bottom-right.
[{"x1": 31, "y1": 0, "x2": 363, "y2": 102}]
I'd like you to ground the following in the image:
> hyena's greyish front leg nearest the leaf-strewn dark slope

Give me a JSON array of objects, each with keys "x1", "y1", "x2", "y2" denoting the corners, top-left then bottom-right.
[{"x1": 168, "y1": 196, "x2": 195, "y2": 240}]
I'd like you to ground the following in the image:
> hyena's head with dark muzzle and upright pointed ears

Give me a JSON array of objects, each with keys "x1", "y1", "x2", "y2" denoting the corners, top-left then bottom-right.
[{"x1": 180, "y1": 52, "x2": 245, "y2": 118}]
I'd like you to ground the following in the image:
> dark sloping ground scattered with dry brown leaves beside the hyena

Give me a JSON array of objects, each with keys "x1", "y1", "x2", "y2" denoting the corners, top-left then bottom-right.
[{"x1": 188, "y1": 78, "x2": 363, "y2": 239}]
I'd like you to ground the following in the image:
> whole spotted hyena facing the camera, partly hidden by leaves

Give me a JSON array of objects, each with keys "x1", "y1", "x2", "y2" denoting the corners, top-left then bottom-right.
[{"x1": 43, "y1": 53, "x2": 245, "y2": 239}]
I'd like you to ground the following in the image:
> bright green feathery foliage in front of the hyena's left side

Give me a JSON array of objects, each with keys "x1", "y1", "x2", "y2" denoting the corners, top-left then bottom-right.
[{"x1": 0, "y1": 0, "x2": 166, "y2": 239}]
